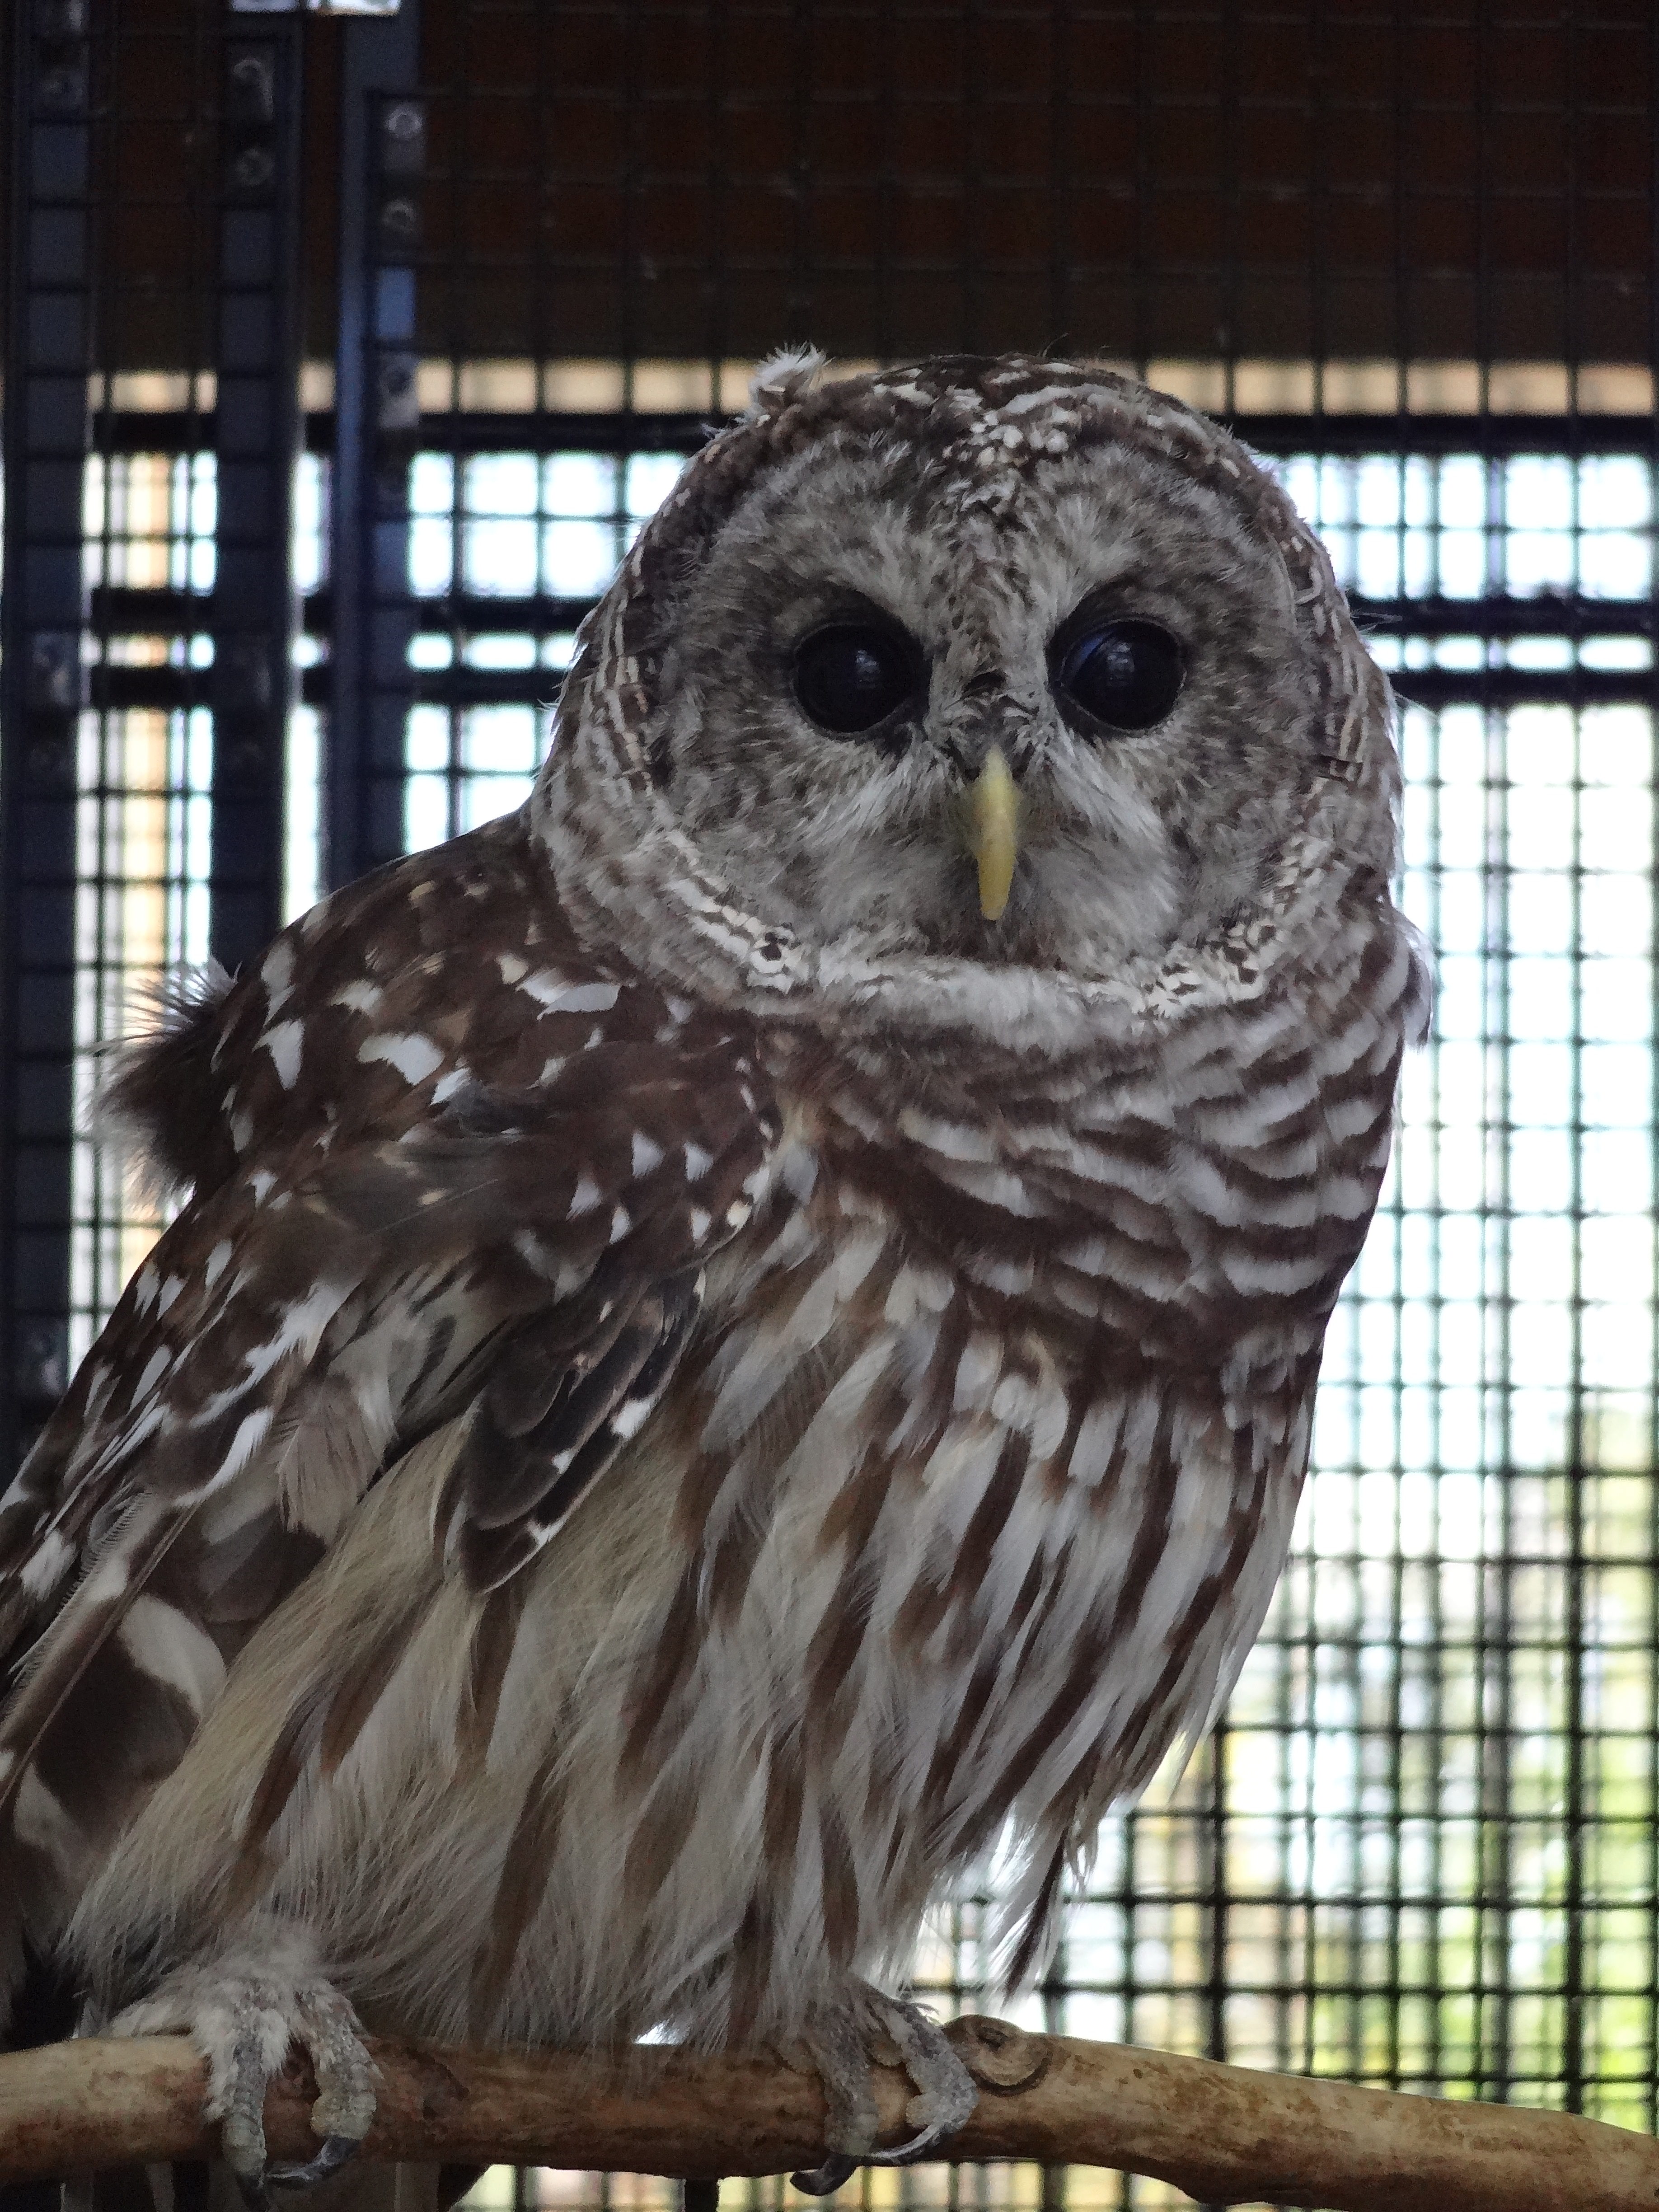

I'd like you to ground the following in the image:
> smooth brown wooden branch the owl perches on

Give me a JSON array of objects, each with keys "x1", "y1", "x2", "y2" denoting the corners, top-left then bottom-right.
[{"x1": 0, "y1": 2020, "x2": 1659, "y2": 2212}]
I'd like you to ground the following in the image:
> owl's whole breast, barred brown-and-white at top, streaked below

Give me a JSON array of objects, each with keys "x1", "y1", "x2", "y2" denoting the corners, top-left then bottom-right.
[{"x1": 575, "y1": 964, "x2": 1398, "y2": 2008}]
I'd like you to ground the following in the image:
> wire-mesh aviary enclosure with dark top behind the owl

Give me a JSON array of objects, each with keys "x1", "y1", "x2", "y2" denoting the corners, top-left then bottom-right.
[{"x1": 0, "y1": 0, "x2": 1659, "y2": 2212}]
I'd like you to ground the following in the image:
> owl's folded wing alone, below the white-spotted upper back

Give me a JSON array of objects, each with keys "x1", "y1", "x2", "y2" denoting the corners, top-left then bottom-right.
[{"x1": 0, "y1": 978, "x2": 778, "y2": 1911}]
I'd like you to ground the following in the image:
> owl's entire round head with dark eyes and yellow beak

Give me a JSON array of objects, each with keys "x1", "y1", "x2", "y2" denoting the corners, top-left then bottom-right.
[{"x1": 533, "y1": 356, "x2": 1398, "y2": 1042}]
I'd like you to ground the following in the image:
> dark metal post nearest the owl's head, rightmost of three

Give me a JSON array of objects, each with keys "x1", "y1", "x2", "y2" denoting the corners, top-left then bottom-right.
[{"x1": 323, "y1": 0, "x2": 427, "y2": 885}]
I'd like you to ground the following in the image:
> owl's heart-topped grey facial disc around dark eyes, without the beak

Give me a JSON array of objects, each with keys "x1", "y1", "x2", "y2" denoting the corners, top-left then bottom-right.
[{"x1": 652, "y1": 431, "x2": 1314, "y2": 975}]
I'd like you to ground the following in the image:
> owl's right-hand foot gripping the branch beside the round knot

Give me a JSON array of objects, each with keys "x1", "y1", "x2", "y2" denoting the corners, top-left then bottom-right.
[{"x1": 790, "y1": 1982, "x2": 980, "y2": 2197}]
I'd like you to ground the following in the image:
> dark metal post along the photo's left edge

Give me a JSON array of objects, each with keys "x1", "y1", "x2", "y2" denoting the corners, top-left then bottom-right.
[{"x1": 0, "y1": 0, "x2": 91, "y2": 1484}]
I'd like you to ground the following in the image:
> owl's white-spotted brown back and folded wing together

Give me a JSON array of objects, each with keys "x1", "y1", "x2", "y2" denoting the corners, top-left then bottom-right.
[{"x1": 0, "y1": 825, "x2": 776, "y2": 1984}]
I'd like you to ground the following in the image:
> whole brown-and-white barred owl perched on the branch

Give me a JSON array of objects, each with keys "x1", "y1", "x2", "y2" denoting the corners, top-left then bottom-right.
[{"x1": 0, "y1": 356, "x2": 1427, "y2": 2203}]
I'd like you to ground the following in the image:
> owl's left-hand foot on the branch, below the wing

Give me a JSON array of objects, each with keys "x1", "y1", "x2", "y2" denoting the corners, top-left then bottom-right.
[{"x1": 104, "y1": 1931, "x2": 374, "y2": 2212}]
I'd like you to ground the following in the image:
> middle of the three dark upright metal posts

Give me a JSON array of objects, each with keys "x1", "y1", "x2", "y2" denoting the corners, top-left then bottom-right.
[{"x1": 208, "y1": 11, "x2": 303, "y2": 969}]
